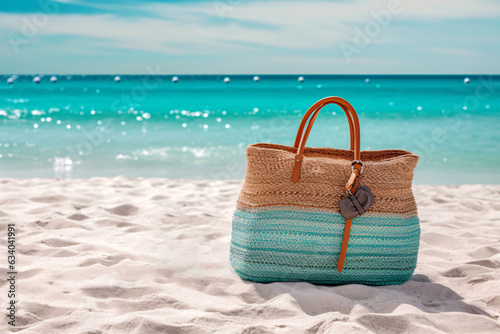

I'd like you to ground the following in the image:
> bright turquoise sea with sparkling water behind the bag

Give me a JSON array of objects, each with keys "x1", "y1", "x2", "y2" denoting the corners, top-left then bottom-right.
[{"x1": 0, "y1": 75, "x2": 500, "y2": 184}]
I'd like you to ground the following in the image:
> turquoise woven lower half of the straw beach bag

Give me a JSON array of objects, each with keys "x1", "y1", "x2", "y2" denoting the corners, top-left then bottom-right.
[{"x1": 230, "y1": 207, "x2": 420, "y2": 285}]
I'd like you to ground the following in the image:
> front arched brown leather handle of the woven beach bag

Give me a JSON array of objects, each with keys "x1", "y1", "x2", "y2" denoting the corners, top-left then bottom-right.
[{"x1": 292, "y1": 96, "x2": 361, "y2": 184}]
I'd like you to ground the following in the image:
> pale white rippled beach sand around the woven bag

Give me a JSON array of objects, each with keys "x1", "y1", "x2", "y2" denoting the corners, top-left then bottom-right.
[{"x1": 0, "y1": 177, "x2": 500, "y2": 334}]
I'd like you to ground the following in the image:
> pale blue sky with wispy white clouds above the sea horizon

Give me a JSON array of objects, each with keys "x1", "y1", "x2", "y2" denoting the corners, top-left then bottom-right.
[{"x1": 0, "y1": 0, "x2": 500, "y2": 74}]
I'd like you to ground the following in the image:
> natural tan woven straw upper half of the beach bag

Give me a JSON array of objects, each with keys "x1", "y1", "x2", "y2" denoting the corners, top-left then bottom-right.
[{"x1": 237, "y1": 98, "x2": 418, "y2": 217}]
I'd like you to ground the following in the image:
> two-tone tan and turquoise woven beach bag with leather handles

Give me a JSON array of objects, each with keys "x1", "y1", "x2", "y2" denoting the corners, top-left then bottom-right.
[{"x1": 230, "y1": 97, "x2": 420, "y2": 285}]
